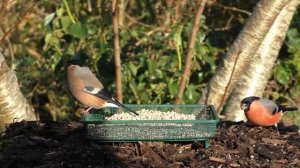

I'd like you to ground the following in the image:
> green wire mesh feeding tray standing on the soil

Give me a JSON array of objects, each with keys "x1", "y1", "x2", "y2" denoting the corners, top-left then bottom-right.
[{"x1": 83, "y1": 104, "x2": 218, "y2": 147}]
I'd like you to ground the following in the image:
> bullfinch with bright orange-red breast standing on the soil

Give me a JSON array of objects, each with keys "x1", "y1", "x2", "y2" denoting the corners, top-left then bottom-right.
[{"x1": 241, "y1": 96, "x2": 297, "y2": 134}]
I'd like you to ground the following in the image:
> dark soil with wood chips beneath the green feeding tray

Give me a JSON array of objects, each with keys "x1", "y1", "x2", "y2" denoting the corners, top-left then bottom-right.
[{"x1": 0, "y1": 122, "x2": 300, "y2": 168}]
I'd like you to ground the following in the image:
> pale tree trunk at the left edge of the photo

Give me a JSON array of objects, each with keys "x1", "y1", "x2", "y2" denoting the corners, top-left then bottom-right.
[{"x1": 0, "y1": 50, "x2": 37, "y2": 132}]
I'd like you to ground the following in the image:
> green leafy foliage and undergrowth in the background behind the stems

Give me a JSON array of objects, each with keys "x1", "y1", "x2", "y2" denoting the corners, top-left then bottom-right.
[{"x1": 1, "y1": 0, "x2": 300, "y2": 124}]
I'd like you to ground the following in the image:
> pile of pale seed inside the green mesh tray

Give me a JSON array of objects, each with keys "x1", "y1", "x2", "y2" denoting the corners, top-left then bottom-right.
[{"x1": 105, "y1": 109, "x2": 196, "y2": 120}]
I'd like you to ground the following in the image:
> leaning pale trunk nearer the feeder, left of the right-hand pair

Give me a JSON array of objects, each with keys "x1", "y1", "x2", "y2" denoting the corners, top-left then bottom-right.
[{"x1": 200, "y1": 0, "x2": 291, "y2": 113}]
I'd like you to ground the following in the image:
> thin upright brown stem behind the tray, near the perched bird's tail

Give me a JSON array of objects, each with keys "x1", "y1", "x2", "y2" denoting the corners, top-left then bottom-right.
[{"x1": 111, "y1": 0, "x2": 123, "y2": 102}]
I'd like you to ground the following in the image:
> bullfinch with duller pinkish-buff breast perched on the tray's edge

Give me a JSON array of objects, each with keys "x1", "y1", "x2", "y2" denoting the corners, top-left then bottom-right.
[{"x1": 66, "y1": 60, "x2": 138, "y2": 115}]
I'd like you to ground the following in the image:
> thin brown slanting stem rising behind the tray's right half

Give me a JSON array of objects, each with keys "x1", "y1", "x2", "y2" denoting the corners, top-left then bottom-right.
[{"x1": 175, "y1": 0, "x2": 206, "y2": 104}]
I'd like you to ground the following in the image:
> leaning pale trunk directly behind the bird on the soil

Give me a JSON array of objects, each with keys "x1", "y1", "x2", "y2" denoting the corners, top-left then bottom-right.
[{"x1": 223, "y1": 0, "x2": 299, "y2": 121}]
